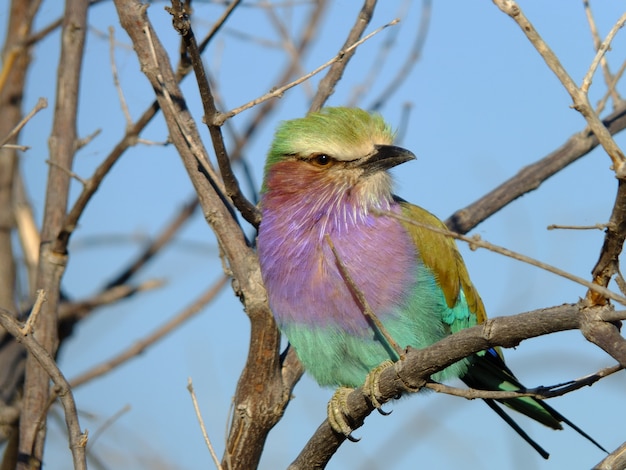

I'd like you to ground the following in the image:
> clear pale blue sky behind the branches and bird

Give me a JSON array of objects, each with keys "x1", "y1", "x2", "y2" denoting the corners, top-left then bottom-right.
[{"x1": 0, "y1": 0, "x2": 626, "y2": 470}]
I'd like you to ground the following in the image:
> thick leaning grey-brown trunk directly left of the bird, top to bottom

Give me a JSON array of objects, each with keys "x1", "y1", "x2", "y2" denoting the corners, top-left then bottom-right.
[{"x1": 115, "y1": 0, "x2": 288, "y2": 469}]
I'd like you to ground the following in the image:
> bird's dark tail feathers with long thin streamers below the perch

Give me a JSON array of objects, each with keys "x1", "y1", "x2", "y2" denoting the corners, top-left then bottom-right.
[{"x1": 461, "y1": 349, "x2": 607, "y2": 459}]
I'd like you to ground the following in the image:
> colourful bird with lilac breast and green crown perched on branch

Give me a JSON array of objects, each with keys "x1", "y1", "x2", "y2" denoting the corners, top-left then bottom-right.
[{"x1": 256, "y1": 107, "x2": 606, "y2": 458}]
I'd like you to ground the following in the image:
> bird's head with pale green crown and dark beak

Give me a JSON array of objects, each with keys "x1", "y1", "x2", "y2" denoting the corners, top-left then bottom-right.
[{"x1": 262, "y1": 108, "x2": 415, "y2": 210}]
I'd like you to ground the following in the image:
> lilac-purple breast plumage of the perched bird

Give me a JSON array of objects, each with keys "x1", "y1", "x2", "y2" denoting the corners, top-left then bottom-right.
[{"x1": 258, "y1": 203, "x2": 417, "y2": 335}]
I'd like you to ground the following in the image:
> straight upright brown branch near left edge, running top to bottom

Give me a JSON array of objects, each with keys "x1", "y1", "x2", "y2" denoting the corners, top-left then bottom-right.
[{"x1": 17, "y1": 0, "x2": 88, "y2": 470}]
